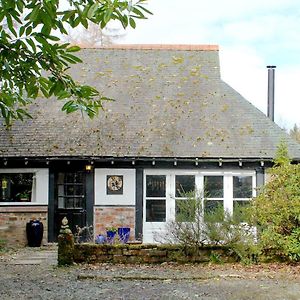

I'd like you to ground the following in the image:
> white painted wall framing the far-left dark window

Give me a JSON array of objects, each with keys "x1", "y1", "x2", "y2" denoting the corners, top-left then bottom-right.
[{"x1": 0, "y1": 168, "x2": 49, "y2": 206}]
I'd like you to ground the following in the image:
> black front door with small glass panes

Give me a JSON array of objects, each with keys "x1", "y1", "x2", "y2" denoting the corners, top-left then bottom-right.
[{"x1": 54, "y1": 171, "x2": 87, "y2": 238}]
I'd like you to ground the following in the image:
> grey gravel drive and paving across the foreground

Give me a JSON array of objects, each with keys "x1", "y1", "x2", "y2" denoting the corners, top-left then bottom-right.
[{"x1": 0, "y1": 248, "x2": 300, "y2": 300}]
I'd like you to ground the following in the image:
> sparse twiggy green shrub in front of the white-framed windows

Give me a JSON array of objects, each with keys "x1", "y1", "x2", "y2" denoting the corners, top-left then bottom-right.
[{"x1": 164, "y1": 193, "x2": 258, "y2": 263}]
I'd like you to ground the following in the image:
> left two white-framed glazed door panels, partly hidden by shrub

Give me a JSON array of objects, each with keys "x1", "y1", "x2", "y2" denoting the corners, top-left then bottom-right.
[{"x1": 143, "y1": 170, "x2": 199, "y2": 243}]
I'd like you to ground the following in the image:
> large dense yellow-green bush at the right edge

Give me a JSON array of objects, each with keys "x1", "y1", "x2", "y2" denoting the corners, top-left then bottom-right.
[{"x1": 253, "y1": 143, "x2": 300, "y2": 261}]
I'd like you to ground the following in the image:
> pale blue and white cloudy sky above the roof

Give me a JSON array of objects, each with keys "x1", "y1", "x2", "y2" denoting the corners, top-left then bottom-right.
[{"x1": 114, "y1": 0, "x2": 300, "y2": 129}]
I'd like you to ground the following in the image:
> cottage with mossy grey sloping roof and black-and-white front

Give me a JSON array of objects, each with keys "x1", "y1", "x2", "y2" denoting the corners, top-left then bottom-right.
[{"x1": 0, "y1": 45, "x2": 300, "y2": 244}]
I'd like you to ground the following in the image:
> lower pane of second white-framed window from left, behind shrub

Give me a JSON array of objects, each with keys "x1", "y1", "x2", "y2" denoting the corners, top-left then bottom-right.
[{"x1": 175, "y1": 199, "x2": 196, "y2": 222}]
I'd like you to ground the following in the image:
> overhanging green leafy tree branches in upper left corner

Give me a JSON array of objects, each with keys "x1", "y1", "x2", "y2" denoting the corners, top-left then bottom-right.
[{"x1": 0, "y1": 0, "x2": 151, "y2": 126}]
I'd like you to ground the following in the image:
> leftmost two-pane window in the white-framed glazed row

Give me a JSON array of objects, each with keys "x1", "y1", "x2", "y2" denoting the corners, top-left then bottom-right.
[{"x1": 146, "y1": 175, "x2": 166, "y2": 222}]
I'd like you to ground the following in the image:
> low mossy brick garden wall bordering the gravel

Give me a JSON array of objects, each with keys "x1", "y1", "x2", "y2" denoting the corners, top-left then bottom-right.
[{"x1": 74, "y1": 244, "x2": 233, "y2": 264}]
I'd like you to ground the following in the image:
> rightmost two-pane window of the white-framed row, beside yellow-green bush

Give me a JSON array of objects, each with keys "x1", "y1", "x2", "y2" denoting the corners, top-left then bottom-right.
[{"x1": 233, "y1": 176, "x2": 253, "y2": 222}]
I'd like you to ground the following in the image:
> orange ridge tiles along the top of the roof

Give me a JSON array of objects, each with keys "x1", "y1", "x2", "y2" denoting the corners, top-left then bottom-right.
[{"x1": 83, "y1": 44, "x2": 219, "y2": 51}]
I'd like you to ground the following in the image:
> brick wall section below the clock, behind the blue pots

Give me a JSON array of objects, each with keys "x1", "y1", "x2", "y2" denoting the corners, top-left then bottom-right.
[{"x1": 94, "y1": 206, "x2": 135, "y2": 240}]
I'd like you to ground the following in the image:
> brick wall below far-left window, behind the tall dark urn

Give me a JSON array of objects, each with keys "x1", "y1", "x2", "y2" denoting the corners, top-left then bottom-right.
[{"x1": 0, "y1": 206, "x2": 48, "y2": 247}]
